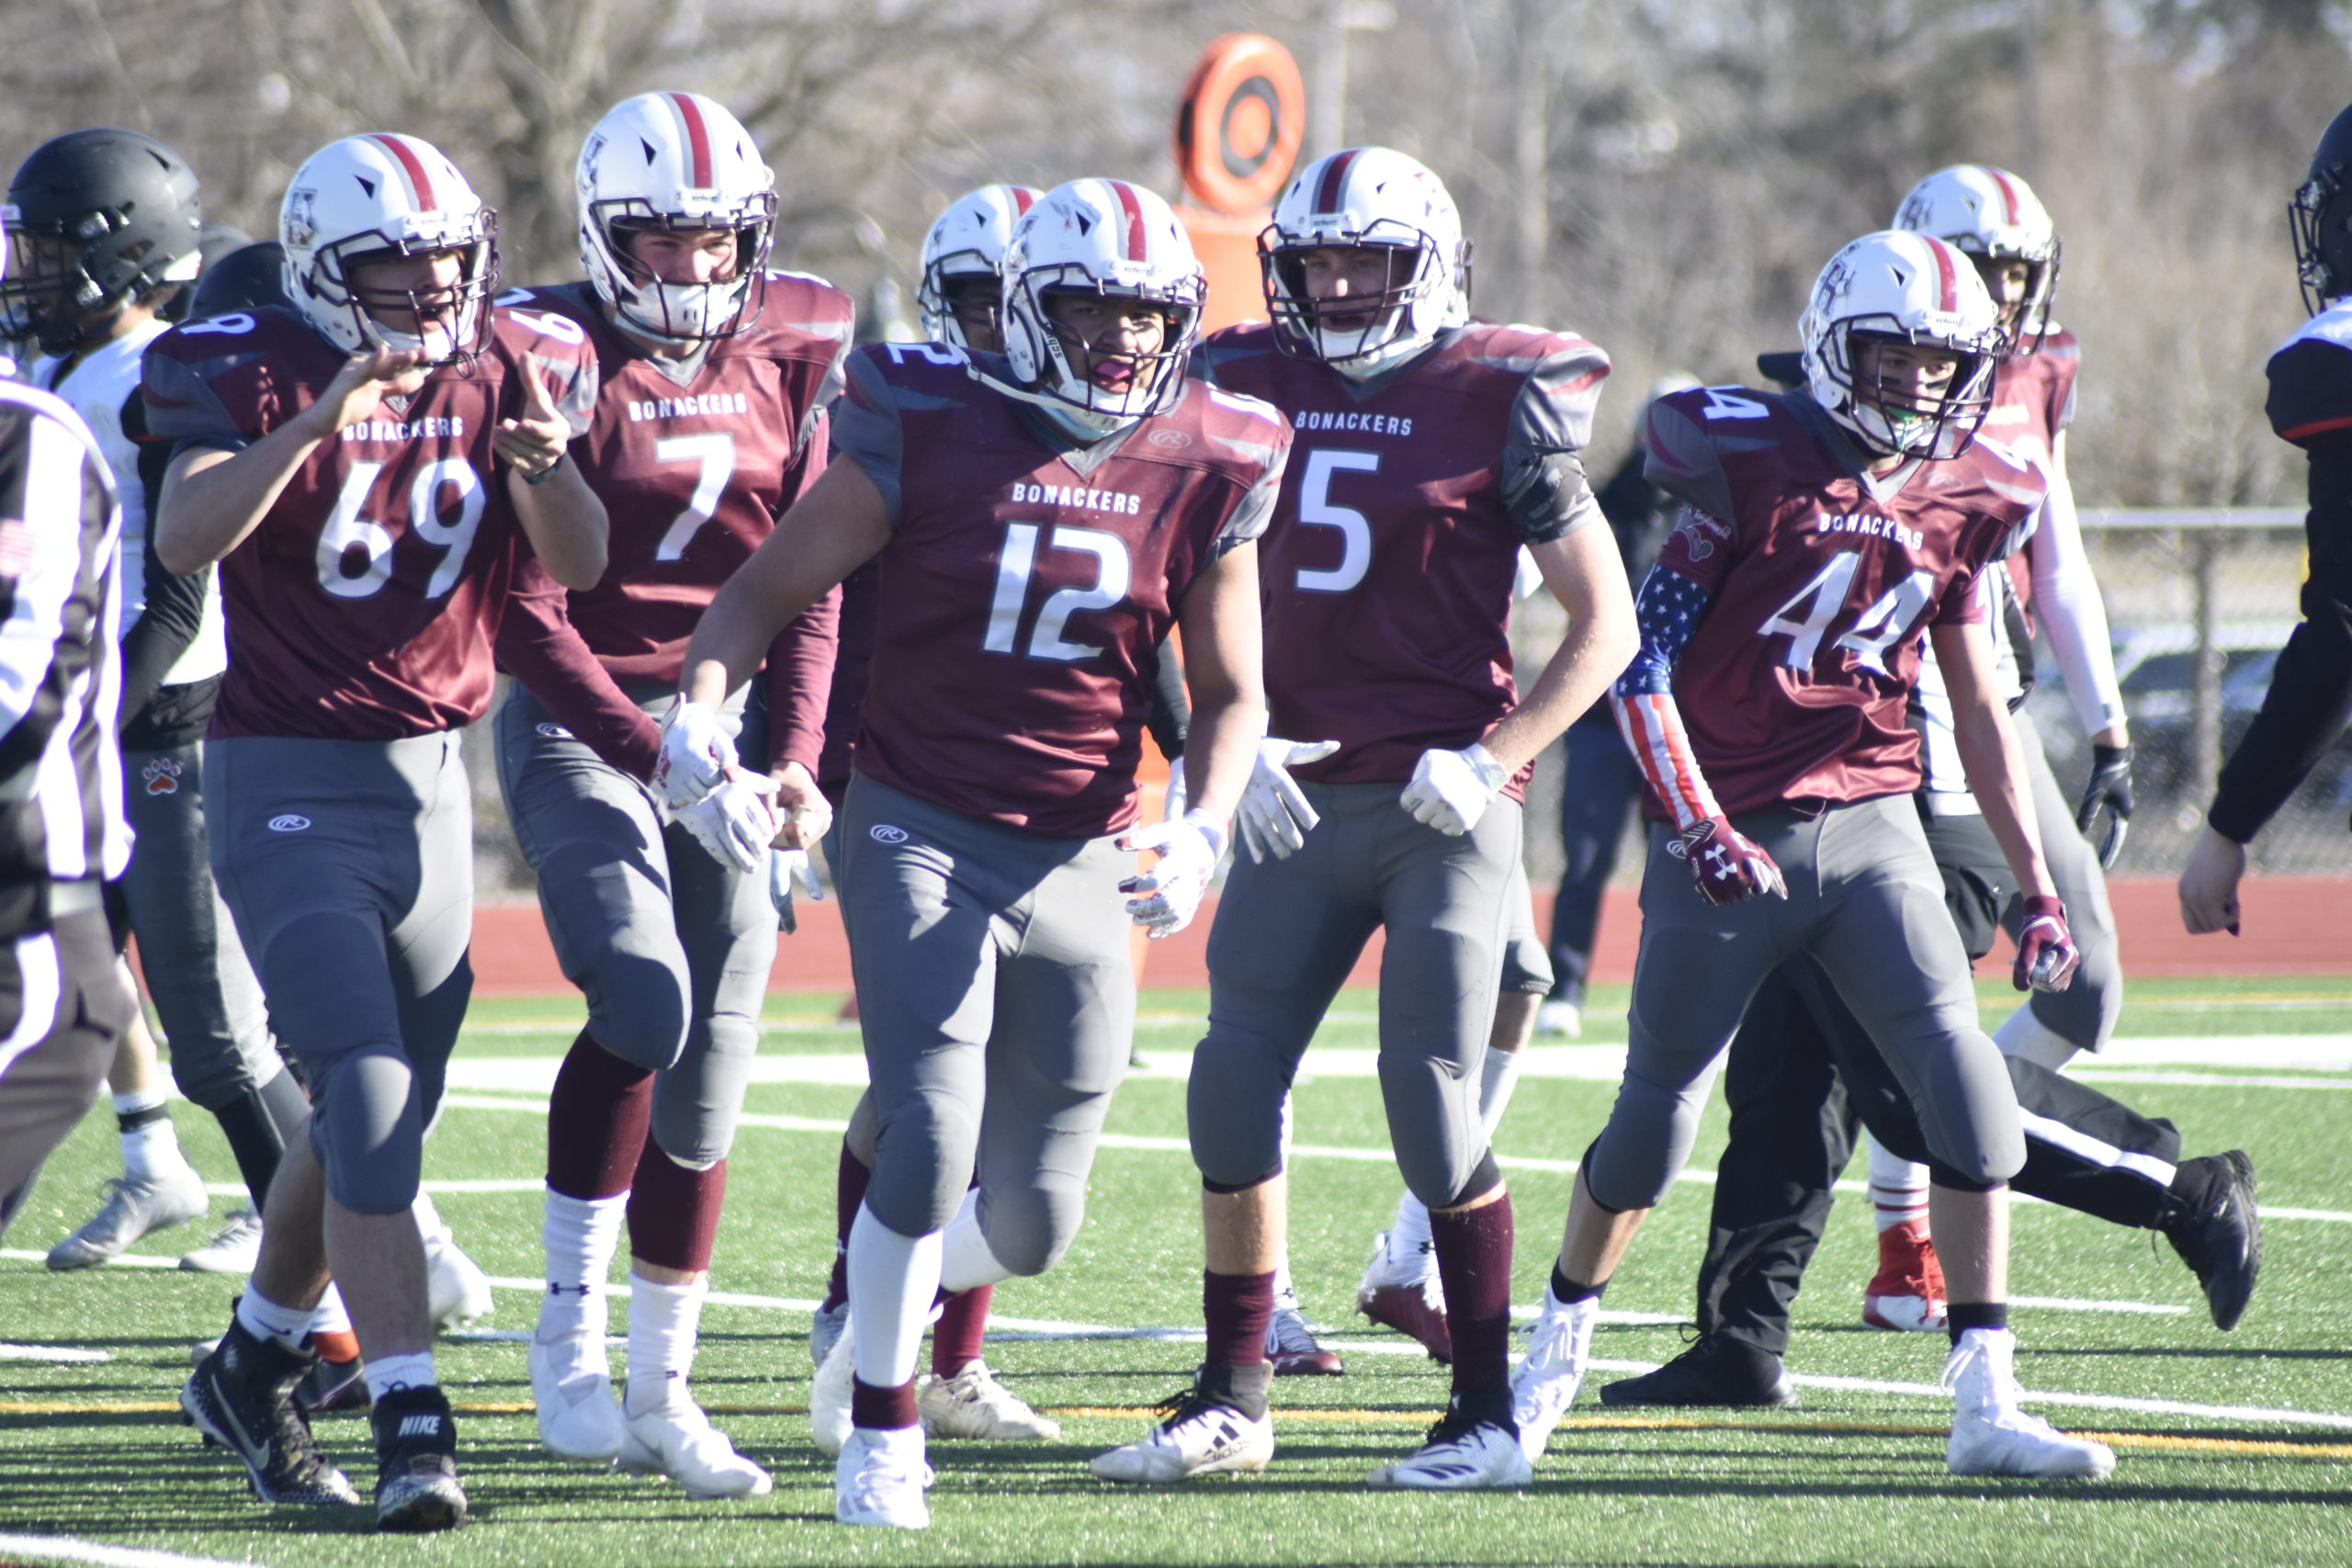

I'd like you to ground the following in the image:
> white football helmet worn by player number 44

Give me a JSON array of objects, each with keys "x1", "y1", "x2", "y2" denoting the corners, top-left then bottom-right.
[{"x1": 1797, "y1": 228, "x2": 2008, "y2": 458}]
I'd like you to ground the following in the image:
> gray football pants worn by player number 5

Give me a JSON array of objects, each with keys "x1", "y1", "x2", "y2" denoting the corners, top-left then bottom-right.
[{"x1": 1188, "y1": 781, "x2": 1520, "y2": 1208}]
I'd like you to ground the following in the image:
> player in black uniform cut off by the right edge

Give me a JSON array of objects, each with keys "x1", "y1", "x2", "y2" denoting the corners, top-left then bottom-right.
[{"x1": 2180, "y1": 108, "x2": 2352, "y2": 936}]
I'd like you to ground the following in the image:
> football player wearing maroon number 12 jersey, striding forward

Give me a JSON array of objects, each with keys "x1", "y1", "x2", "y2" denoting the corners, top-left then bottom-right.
[{"x1": 663, "y1": 179, "x2": 1289, "y2": 1528}]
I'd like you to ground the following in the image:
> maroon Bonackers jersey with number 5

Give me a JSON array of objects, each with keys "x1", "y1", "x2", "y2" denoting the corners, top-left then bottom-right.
[{"x1": 1200, "y1": 324, "x2": 1609, "y2": 799}]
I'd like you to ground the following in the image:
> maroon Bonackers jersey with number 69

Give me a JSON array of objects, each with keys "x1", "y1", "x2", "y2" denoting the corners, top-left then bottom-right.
[{"x1": 143, "y1": 308, "x2": 597, "y2": 740}]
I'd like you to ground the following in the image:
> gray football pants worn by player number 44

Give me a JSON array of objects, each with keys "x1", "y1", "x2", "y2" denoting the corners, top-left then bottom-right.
[{"x1": 1583, "y1": 797, "x2": 2025, "y2": 1211}]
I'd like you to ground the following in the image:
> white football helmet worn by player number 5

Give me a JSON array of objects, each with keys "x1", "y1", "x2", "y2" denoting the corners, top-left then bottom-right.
[{"x1": 1259, "y1": 148, "x2": 1470, "y2": 374}]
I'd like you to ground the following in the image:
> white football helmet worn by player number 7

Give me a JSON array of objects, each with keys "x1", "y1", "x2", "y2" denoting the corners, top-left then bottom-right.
[{"x1": 571, "y1": 92, "x2": 776, "y2": 344}]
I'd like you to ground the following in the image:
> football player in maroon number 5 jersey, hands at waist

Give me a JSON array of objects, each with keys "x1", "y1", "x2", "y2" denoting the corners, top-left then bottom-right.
[{"x1": 1093, "y1": 148, "x2": 1634, "y2": 1488}]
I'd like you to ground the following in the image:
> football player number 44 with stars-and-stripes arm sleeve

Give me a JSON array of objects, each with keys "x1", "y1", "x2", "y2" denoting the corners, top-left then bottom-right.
[{"x1": 1512, "y1": 231, "x2": 2114, "y2": 1479}]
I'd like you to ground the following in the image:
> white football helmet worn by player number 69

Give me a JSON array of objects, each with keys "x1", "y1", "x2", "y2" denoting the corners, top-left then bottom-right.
[{"x1": 277, "y1": 131, "x2": 499, "y2": 365}]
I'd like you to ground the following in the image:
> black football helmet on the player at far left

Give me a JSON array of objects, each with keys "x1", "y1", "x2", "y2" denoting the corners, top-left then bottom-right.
[{"x1": 0, "y1": 127, "x2": 202, "y2": 355}]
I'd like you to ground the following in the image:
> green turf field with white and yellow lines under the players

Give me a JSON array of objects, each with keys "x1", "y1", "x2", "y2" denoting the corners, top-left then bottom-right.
[{"x1": 0, "y1": 978, "x2": 2352, "y2": 1568}]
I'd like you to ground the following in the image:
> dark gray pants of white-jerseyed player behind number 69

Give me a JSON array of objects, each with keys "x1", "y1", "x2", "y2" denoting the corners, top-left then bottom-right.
[{"x1": 122, "y1": 743, "x2": 285, "y2": 1112}]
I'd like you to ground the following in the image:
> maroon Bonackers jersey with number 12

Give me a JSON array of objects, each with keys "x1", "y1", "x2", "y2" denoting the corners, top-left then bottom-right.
[{"x1": 832, "y1": 344, "x2": 1289, "y2": 840}]
